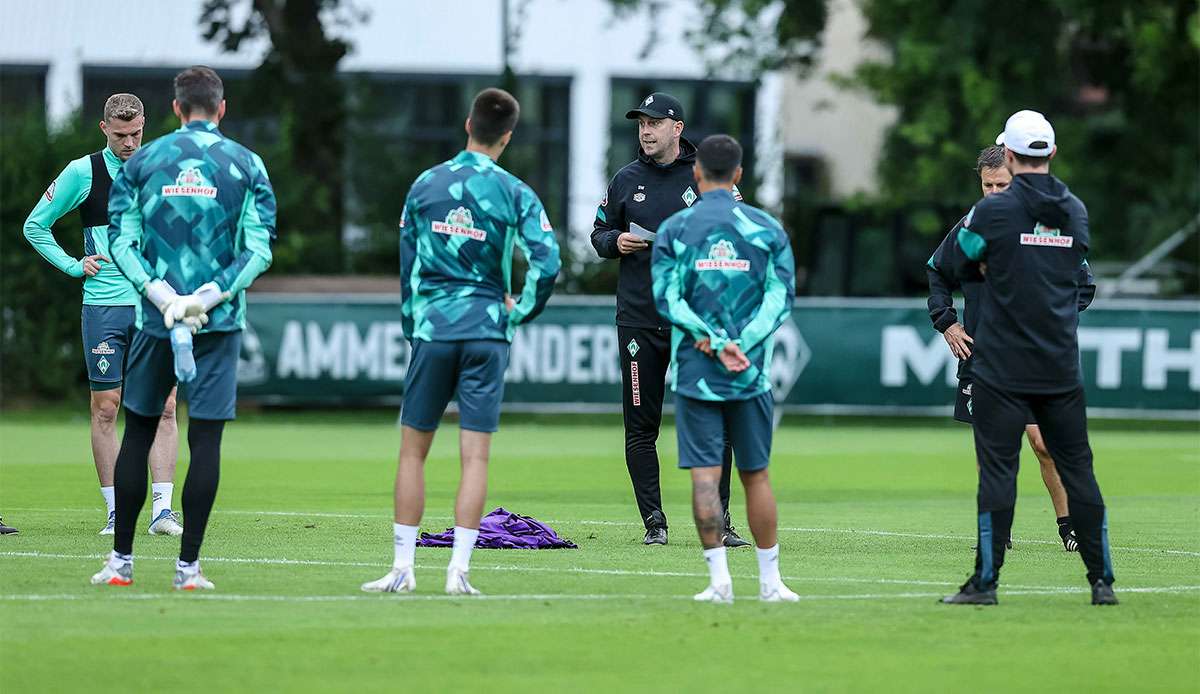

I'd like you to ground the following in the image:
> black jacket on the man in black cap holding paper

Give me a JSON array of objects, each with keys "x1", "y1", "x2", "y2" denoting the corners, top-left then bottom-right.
[{"x1": 592, "y1": 138, "x2": 729, "y2": 330}]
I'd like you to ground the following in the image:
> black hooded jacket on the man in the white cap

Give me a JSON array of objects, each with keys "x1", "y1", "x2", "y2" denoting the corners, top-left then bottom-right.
[{"x1": 955, "y1": 174, "x2": 1094, "y2": 393}]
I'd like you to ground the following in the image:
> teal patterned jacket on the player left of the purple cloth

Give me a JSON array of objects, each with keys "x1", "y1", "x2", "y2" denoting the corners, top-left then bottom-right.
[{"x1": 400, "y1": 150, "x2": 562, "y2": 342}]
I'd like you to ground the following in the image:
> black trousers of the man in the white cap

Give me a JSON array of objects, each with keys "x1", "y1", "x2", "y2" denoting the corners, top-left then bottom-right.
[{"x1": 972, "y1": 381, "x2": 1114, "y2": 588}]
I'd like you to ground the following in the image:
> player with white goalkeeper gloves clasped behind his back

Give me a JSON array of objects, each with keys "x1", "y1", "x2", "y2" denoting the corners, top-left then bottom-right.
[{"x1": 91, "y1": 66, "x2": 275, "y2": 591}]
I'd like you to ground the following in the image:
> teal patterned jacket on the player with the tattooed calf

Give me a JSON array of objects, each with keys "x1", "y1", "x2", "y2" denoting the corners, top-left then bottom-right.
[{"x1": 650, "y1": 189, "x2": 796, "y2": 401}]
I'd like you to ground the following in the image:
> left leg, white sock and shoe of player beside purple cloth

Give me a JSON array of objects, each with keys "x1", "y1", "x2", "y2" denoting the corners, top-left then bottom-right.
[{"x1": 362, "y1": 426, "x2": 434, "y2": 593}]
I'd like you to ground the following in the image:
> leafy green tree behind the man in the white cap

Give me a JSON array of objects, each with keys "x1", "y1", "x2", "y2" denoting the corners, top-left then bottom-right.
[{"x1": 853, "y1": 0, "x2": 1200, "y2": 270}]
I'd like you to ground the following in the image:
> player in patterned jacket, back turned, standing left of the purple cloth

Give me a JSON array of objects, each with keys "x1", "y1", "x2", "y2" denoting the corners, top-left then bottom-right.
[{"x1": 362, "y1": 89, "x2": 562, "y2": 596}]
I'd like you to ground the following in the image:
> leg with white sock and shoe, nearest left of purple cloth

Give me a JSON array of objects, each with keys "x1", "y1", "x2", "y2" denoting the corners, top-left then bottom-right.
[{"x1": 446, "y1": 429, "x2": 492, "y2": 596}]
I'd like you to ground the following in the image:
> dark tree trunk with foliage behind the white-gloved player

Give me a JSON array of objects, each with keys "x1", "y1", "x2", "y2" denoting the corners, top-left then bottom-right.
[{"x1": 200, "y1": 0, "x2": 367, "y2": 273}]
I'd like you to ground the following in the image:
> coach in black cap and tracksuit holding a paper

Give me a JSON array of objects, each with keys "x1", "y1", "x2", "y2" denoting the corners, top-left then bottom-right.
[{"x1": 592, "y1": 91, "x2": 750, "y2": 546}]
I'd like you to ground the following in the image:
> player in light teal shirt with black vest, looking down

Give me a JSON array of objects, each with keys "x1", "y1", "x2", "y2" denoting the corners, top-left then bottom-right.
[{"x1": 24, "y1": 94, "x2": 184, "y2": 536}]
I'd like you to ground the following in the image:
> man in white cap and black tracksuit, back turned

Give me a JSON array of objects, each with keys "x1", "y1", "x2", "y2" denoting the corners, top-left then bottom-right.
[{"x1": 942, "y1": 110, "x2": 1117, "y2": 605}]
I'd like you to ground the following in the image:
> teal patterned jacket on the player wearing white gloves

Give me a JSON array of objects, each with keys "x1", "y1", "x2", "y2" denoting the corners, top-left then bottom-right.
[{"x1": 108, "y1": 120, "x2": 275, "y2": 337}]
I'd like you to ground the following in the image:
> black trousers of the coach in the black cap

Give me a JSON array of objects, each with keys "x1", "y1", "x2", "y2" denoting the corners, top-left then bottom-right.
[{"x1": 617, "y1": 325, "x2": 733, "y2": 527}]
